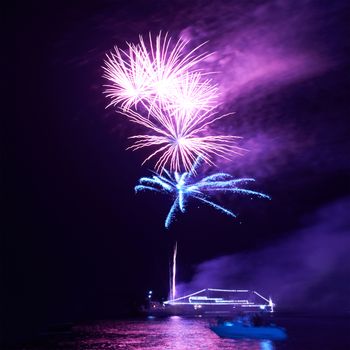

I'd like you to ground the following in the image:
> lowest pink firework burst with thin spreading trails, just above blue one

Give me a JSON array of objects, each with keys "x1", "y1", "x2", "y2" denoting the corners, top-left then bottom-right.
[{"x1": 121, "y1": 107, "x2": 242, "y2": 173}]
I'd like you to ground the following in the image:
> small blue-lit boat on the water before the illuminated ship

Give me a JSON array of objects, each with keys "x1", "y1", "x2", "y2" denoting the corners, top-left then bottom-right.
[{"x1": 210, "y1": 321, "x2": 287, "y2": 340}]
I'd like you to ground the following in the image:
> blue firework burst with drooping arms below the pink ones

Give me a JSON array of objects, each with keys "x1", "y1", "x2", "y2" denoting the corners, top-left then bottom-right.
[{"x1": 135, "y1": 159, "x2": 271, "y2": 228}]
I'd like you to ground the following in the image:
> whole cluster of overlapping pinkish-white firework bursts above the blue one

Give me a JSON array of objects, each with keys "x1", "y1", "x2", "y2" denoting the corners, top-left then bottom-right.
[{"x1": 103, "y1": 34, "x2": 242, "y2": 173}]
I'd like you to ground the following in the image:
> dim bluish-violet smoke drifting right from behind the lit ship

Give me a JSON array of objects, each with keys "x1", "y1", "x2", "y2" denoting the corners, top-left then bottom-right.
[{"x1": 177, "y1": 197, "x2": 350, "y2": 312}]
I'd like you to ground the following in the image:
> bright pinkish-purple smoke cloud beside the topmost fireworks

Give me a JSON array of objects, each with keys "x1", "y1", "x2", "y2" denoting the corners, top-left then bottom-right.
[{"x1": 181, "y1": 1, "x2": 339, "y2": 103}]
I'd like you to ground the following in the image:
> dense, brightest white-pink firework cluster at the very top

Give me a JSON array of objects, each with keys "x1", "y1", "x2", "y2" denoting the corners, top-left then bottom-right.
[{"x1": 102, "y1": 33, "x2": 217, "y2": 112}]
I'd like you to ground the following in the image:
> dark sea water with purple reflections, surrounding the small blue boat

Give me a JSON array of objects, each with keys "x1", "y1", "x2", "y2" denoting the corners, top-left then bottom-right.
[{"x1": 17, "y1": 316, "x2": 350, "y2": 350}]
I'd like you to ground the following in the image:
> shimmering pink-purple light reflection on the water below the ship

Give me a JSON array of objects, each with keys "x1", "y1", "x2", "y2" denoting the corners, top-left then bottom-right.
[{"x1": 76, "y1": 316, "x2": 275, "y2": 350}]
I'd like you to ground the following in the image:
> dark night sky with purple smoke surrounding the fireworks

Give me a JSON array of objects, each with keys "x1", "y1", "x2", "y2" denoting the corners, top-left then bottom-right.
[{"x1": 1, "y1": 0, "x2": 350, "y2": 339}]
